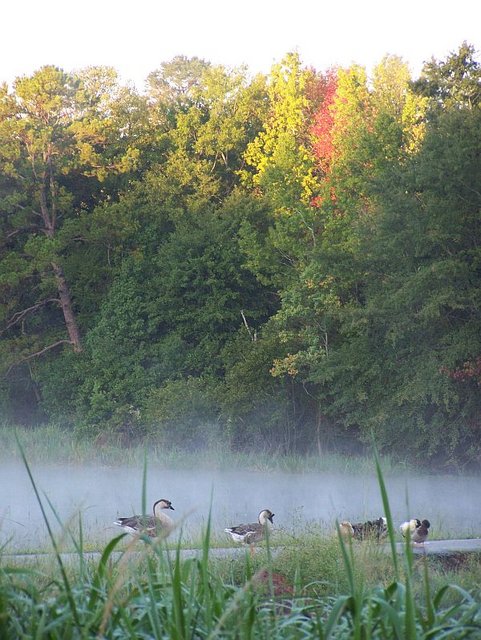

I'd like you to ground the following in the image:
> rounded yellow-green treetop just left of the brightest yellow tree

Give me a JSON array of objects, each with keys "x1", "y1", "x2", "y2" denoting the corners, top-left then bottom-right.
[{"x1": 139, "y1": 56, "x2": 265, "y2": 220}]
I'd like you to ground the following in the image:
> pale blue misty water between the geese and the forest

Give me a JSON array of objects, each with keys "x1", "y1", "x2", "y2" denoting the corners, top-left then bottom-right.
[{"x1": 0, "y1": 463, "x2": 481, "y2": 550}]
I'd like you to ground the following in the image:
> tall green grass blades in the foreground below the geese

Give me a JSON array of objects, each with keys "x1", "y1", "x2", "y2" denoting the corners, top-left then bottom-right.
[{"x1": 0, "y1": 442, "x2": 481, "y2": 640}]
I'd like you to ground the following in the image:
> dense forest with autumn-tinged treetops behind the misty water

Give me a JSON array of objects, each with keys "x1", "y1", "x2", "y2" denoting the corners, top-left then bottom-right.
[{"x1": 0, "y1": 43, "x2": 481, "y2": 464}]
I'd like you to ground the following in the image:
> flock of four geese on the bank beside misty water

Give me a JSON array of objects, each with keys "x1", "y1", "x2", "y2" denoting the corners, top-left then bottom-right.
[{"x1": 114, "y1": 498, "x2": 431, "y2": 553}]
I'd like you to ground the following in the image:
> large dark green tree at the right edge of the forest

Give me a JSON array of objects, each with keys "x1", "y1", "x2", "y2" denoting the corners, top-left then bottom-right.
[{"x1": 344, "y1": 104, "x2": 481, "y2": 457}]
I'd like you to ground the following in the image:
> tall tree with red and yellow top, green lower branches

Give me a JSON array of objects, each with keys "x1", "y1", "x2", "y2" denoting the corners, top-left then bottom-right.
[{"x1": 271, "y1": 58, "x2": 425, "y2": 450}]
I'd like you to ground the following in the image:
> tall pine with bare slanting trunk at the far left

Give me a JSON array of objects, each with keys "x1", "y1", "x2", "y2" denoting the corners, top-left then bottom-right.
[{"x1": 0, "y1": 67, "x2": 81, "y2": 358}]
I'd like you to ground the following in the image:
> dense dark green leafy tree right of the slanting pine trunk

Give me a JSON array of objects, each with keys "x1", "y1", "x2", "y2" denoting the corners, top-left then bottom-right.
[{"x1": 70, "y1": 195, "x2": 270, "y2": 436}]
